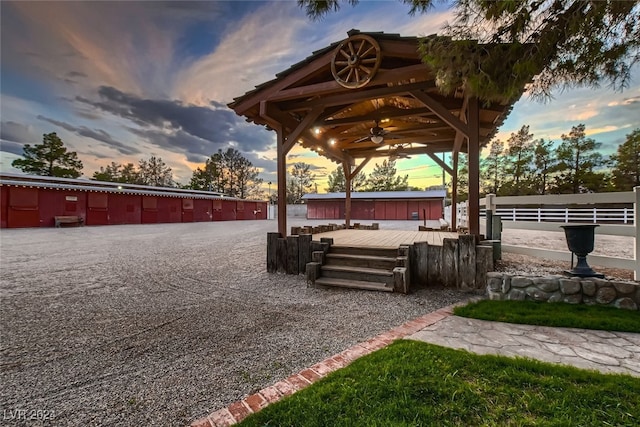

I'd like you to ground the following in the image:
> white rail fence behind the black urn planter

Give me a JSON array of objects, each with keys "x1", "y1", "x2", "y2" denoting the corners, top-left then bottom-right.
[{"x1": 445, "y1": 187, "x2": 640, "y2": 280}]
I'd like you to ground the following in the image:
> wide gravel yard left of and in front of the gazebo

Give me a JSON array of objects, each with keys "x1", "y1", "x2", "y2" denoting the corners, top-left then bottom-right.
[{"x1": 0, "y1": 220, "x2": 467, "y2": 426}]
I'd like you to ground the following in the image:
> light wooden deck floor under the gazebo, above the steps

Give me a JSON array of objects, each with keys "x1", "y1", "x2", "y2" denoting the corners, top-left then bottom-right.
[{"x1": 314, "y1": 230, "x2": 458, "y2": 248}]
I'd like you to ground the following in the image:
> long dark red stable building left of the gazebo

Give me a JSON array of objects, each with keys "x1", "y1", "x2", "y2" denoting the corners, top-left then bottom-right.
[{"x1": 0, "y1": 174, "x2": 267, "y2": 228}]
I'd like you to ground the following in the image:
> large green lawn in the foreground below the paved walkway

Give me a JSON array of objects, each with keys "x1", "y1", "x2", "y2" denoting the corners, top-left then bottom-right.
[{"x1": 240, "y1": 340, "x2": 640, "y2": 426}]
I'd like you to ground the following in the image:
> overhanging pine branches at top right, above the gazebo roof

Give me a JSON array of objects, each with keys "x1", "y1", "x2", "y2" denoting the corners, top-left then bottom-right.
[{"x1": 298, "y1": 0, "x2": 640, "y2": 101}]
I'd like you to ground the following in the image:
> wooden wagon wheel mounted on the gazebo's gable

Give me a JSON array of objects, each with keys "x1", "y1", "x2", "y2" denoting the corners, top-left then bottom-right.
[{"x1": 331, "y1": 34, "x2": 382, "y2": 89}]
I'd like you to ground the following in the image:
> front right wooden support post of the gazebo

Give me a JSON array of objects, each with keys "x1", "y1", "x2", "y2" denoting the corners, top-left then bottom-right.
[{"x1": 467, "y1": 97, "x2": 480, "y2": 240}]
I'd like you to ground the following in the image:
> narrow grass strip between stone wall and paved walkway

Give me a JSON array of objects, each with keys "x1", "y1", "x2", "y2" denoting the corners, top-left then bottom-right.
[{"x1": 453, "y1": 300, "x2": 640, "y2": 333}]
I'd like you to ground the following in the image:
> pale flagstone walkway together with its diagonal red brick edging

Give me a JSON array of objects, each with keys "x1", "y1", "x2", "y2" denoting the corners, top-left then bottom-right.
[{"x1": 191, "y1": 307, "x2": 640, "y2": 427}]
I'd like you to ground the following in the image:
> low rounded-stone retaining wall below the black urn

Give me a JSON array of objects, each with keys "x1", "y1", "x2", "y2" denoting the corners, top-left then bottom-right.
[{"x1": 487, "y1": 272, "x2": 640, "y2": 310}]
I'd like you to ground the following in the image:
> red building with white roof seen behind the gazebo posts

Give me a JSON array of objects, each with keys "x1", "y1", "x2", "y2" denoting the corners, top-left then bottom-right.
[{"x1": 302, "y1": 190, "x2": 446, "y2": 220}]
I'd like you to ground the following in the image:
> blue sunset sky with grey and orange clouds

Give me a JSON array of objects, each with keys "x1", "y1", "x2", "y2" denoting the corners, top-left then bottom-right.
[{"x1": 0, "y1": 0, "x2": 640, "y2": 191}]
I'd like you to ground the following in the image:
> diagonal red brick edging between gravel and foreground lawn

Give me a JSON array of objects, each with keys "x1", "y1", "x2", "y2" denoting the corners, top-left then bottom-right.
[{"x1": 191, "y1": 305, "x2": 454, "y2": 427}]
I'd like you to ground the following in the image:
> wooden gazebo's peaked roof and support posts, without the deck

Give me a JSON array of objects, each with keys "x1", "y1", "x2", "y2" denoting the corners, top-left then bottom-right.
[{"x1": 229, "y1": 30, "x2": 514, "y2": 236}]
